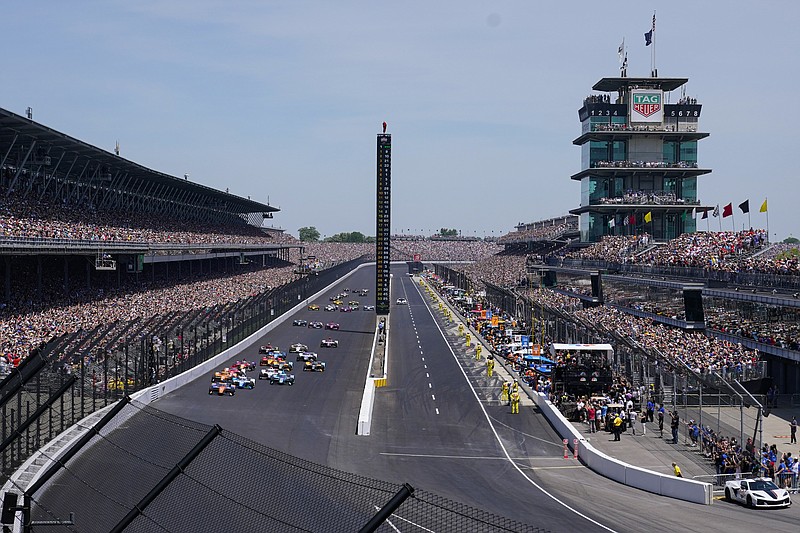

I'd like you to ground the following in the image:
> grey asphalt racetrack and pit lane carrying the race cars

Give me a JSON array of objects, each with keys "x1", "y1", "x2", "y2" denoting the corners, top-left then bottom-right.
[{"x1": 36, "y1": 268, "x2": 800, "y2": 532}]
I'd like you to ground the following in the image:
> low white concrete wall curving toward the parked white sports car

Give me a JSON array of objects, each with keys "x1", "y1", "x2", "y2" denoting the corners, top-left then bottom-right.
[{"x1": 424, "y1": 276, "x2": 713, "y2": 505}]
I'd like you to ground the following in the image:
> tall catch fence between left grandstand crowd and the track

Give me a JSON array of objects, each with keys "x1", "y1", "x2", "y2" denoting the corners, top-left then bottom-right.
[{"x1": 0, "y1": 260, "x2": 363, "y2": 481}]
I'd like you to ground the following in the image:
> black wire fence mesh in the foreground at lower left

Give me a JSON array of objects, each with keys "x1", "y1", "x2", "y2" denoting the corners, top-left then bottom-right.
[{"x1": 17, "y1": 403, "x2": 545, "y2": 533}]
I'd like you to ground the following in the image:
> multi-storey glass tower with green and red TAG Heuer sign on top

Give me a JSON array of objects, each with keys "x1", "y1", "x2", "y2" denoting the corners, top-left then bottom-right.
[{"x1": 570, "y1": 77, "x2": 711, "y2": 242}]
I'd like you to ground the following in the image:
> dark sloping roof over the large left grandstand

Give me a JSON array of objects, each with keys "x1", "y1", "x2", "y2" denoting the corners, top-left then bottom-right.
[{"x1": 0, "y1": 108, "x2": 280, "y2": 213}]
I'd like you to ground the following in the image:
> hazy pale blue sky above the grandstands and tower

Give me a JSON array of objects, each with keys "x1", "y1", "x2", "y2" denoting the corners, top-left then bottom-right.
[{"x1": 0, "y1": 0, "x2": 800, "y2": 240}]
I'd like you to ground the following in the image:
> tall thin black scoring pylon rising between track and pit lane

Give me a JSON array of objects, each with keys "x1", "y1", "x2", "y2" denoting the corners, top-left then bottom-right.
[{"x1": 375, "y1": 133, "x2": 392, "y2": 315}]
